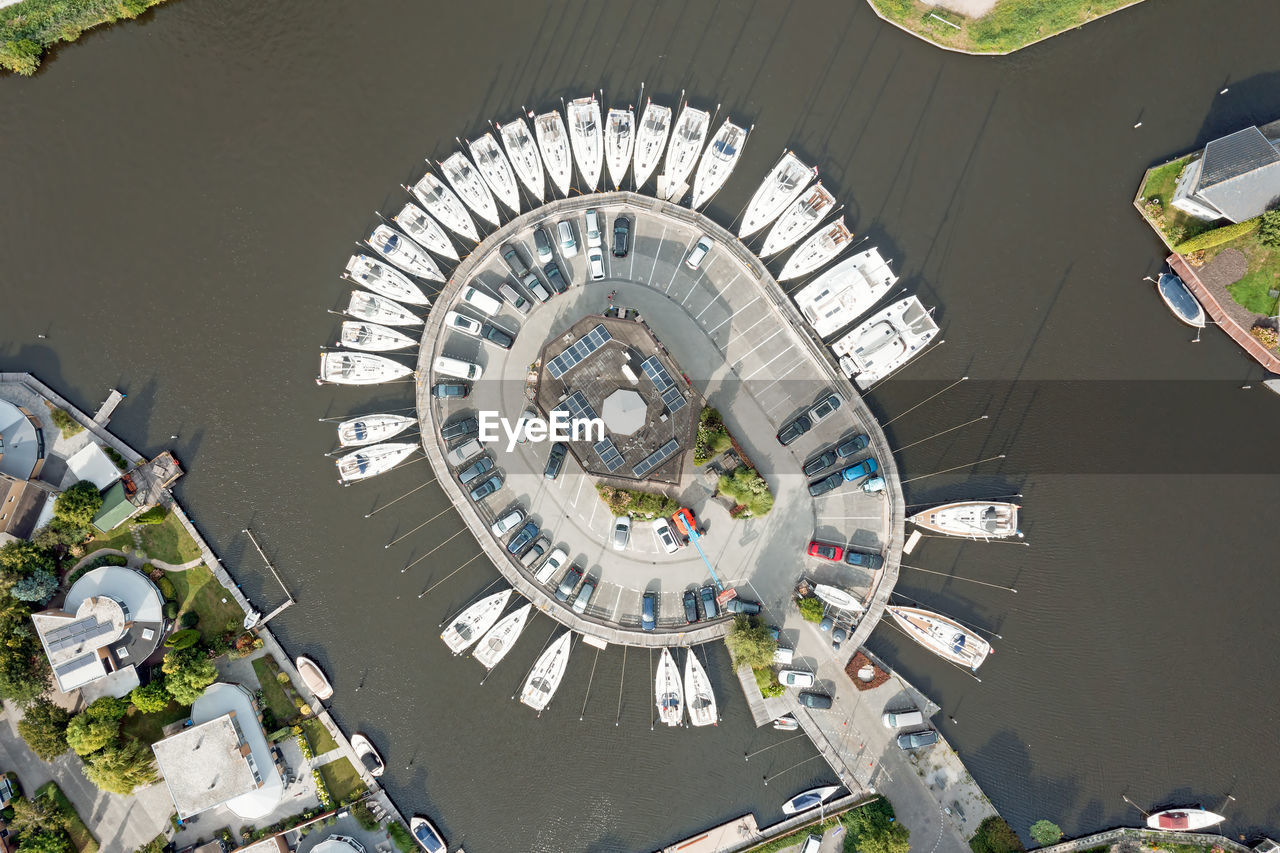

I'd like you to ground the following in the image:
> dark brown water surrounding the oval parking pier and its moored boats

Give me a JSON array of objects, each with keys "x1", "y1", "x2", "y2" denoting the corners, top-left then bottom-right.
[{"x1": 0, "y1": 0, "x2": 1280, "y2": 850}]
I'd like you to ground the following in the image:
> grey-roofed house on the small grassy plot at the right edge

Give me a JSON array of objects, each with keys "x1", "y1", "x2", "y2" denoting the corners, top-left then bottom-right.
[{"x1": 1170, "y1": 122, "x2": 1280, "y2": 222}]
